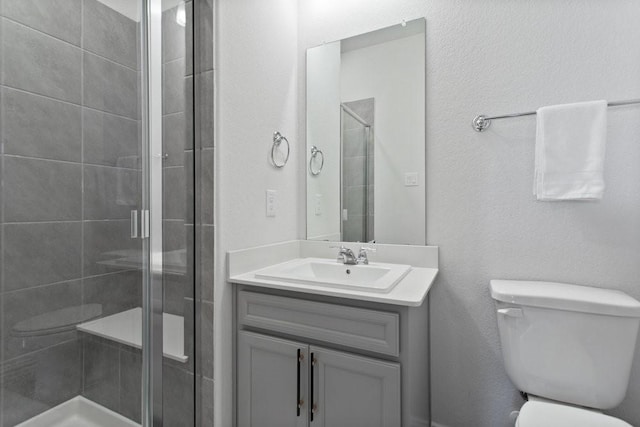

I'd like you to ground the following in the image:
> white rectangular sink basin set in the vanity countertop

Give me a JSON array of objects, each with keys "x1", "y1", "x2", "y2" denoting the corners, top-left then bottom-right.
[{"x1": 255, "y1": 258, "x2": 411, "y2": 293}]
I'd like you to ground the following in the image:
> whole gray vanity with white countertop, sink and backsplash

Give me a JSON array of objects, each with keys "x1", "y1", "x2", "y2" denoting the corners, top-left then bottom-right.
[{"x1": 227, "y1": 240, "x2": 438, "y2": 427}]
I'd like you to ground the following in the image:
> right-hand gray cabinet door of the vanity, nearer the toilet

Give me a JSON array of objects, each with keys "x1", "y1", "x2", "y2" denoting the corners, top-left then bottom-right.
[{"x1": 309, "y1": 346, "x2": 400, "y2": 427}]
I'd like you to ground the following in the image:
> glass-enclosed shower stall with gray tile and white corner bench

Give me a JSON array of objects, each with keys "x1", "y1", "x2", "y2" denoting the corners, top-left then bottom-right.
[{"x1": 0, "y1": 0, "x2": 214, "y2": 427}]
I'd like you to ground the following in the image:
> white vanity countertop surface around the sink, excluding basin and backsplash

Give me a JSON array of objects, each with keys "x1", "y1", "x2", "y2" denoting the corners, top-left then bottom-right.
[{"x1": 229, "y1": 267, "x2": 438, "y2": 307}]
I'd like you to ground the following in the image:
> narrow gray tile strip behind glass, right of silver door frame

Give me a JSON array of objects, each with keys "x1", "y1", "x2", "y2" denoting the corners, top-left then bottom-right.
[{"x1": 162, "y1": 2, "x2": 195, "y2": 426}]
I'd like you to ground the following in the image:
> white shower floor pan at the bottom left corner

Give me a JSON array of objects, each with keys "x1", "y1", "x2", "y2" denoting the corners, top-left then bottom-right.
[{"x1": 16, "y1": 396, "x2": 140, "y2": 427}]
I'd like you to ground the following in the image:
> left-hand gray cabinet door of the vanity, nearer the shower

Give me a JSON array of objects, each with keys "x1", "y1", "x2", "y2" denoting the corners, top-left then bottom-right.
[{"x1": 237, "y1": 331, "x2": 309, "y2": 427}]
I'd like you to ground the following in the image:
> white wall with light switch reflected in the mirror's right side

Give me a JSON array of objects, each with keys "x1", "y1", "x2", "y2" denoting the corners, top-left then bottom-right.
[{"x1": 341, "y1": 34, "x2": 426, "y2": 245}]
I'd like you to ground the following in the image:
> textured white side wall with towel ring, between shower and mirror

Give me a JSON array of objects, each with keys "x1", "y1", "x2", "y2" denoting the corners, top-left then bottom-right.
[{"x1": 214, "y1": 0, "x2": 304, "y2": 427}]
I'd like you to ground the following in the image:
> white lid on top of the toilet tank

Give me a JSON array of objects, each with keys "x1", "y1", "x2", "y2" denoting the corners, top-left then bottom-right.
[{"x1": 490, "y1": 280, "x2": 640, "y2": 317}]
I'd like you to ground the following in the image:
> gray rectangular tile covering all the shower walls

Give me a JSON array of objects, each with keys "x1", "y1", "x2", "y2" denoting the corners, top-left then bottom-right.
[{"x1": 0, "y1": 0, "x2": 214, "y2": 427}]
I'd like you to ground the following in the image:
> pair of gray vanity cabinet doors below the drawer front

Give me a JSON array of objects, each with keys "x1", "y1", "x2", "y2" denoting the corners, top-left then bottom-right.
[{"x1": 237, "y1": 331, "x2": 400, "y2": 427}]
